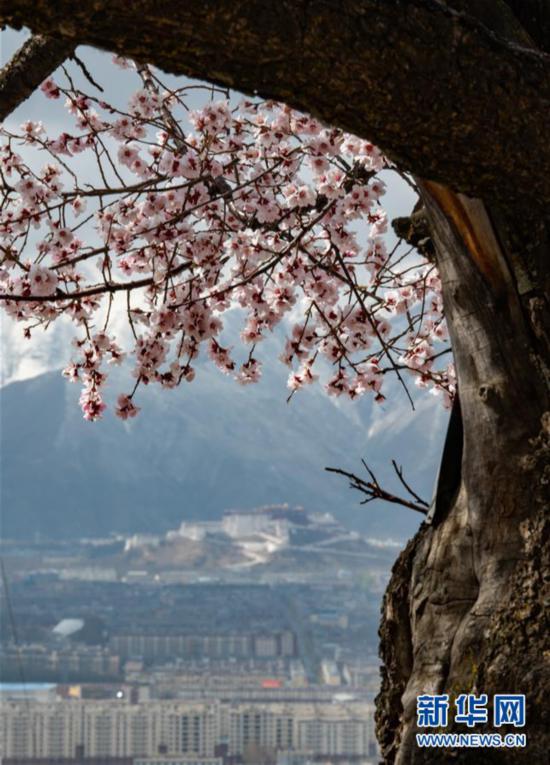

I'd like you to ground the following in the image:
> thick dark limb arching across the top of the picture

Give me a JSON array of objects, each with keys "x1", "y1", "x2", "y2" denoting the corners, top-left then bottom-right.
[{"x1": 0, "y1": 0, "x2": 550, "y2": 205}]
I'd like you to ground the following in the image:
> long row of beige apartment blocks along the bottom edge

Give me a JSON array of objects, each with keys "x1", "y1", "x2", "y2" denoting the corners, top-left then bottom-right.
[{"x1": 0, "y1": 699, "x2": 376, "y2": 761}]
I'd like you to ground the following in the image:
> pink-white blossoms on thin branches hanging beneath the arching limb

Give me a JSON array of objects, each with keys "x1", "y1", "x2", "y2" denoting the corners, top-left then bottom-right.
[{"x1": 0, "y1": 62, "x2": 455, "y2": 420}]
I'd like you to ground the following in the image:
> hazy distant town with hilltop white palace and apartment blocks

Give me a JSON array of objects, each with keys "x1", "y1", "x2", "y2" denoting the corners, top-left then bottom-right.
[{"x1": 0, "y1": 505, "x2": 395, "y2": 765}]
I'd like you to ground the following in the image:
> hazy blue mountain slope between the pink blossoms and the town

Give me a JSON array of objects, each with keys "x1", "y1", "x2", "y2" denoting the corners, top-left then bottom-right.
[{"x1": 0, "y1": 352, "x2": 446, "y2": 539}]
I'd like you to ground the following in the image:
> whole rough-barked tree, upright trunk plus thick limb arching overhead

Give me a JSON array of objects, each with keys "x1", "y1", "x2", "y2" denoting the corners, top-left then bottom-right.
[{"x1": 0, "y1": 0, "x2": 550, "y2": 765}]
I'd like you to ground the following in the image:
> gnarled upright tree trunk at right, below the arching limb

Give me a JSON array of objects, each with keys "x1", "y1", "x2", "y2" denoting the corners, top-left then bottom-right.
[{"x1": 377, "y1": 188, "x2": 550, "y2": 765}]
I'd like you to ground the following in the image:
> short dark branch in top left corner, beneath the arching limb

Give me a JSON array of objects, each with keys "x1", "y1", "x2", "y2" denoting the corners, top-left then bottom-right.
[{"x1": 0, "y1": 35, "x2": 74, "y2": 121}]
